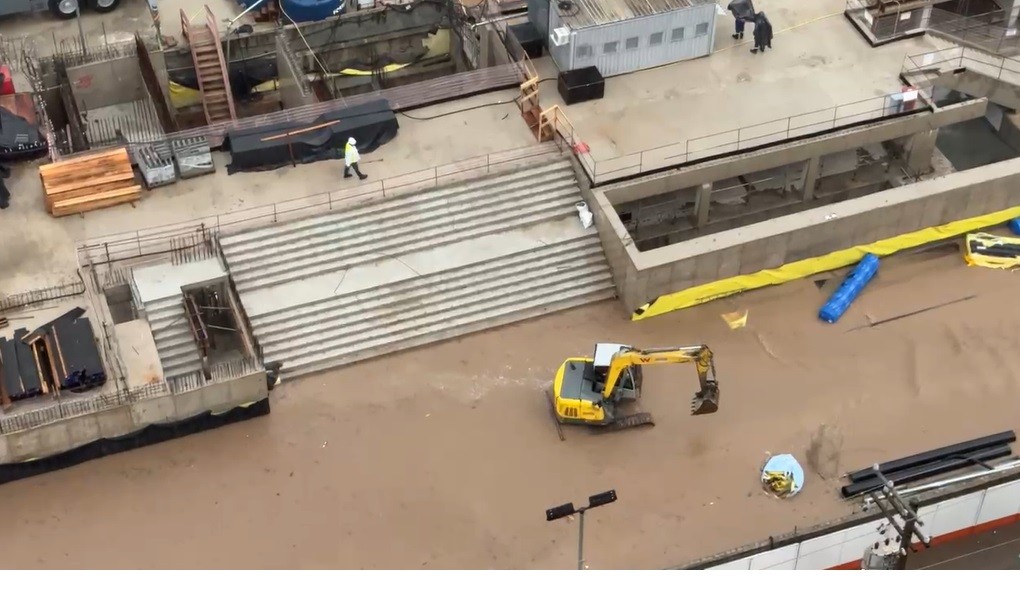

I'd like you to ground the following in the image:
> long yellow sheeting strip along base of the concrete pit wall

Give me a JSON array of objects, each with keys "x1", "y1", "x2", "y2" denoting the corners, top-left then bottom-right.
[{"x1": 630, "y1": 207, "x2": 1020, "y2": 322}]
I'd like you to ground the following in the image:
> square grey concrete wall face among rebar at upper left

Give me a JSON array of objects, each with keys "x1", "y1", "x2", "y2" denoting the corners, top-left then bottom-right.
[{"x1": 67, "y1": 55, "x2": 146, "y2": 111}]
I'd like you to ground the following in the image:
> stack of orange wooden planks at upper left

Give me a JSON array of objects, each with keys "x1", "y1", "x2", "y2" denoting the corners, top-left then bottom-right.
[{"x1": 39, "y1": 148, "x2": 142, "y2": 217}]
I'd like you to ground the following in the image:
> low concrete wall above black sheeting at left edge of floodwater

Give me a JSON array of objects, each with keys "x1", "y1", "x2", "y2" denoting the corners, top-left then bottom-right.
[{"x1": 0, "y1": 372, "x2": 268, "y2": 463}]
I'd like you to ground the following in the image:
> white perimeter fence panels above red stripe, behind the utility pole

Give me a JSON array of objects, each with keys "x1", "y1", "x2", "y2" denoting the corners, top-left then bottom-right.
[{"x1": 708, "y1": 480, "x2": 1020, "y2": 570}]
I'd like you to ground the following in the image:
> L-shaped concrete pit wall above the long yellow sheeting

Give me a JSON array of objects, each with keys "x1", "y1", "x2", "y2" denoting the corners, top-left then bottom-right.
[{"x1": 590, "y1": 158, "x2": 1020, "y2": 309}]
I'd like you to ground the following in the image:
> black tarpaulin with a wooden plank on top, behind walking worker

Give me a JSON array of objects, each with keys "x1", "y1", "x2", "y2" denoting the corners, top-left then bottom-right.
[{"x1": 224, "y1": 100, "x2": 399, "y2": 175}]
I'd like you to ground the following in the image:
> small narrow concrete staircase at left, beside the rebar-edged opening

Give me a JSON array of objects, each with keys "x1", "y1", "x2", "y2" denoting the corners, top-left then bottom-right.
[{"x1": 145, "y1": 295, "x2": 202, "y2": 379}]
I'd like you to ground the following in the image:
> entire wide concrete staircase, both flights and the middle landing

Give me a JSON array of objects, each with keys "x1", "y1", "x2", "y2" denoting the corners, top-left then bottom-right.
[{"x1": 220, "y1": 155, "x2": 615, "y2": 375}]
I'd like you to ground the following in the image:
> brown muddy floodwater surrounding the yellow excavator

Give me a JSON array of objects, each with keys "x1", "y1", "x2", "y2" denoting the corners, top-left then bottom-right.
[{"x1": 0, "y1": 246, "x2": 1020, "y2": 569}]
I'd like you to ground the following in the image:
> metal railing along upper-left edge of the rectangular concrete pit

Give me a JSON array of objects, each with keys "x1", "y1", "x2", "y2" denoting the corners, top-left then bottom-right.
[{"x1": 560, "y1": 89, "x2": 931, "y2": 185}]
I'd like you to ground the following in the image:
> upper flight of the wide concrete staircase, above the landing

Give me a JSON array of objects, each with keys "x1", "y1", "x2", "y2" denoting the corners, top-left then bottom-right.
[{"x1": 220, "y1": 160, "x2": 580, "y2": 293}]
